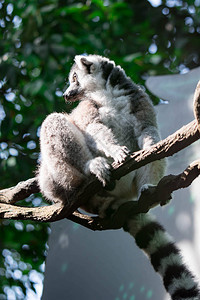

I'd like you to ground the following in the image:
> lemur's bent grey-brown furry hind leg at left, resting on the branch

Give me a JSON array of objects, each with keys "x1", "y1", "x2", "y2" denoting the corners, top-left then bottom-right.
[{"x1": 38, "y1": 113, "x2": 93, "y2": 203}]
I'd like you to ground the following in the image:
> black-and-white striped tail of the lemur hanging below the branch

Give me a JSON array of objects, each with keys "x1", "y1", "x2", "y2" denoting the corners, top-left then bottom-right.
[{"x1": 124, "y1": 214, "x2": 200, "y2": 300}]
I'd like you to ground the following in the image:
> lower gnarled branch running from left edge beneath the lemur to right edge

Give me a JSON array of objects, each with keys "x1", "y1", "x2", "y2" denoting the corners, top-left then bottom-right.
[{"x1": 0, "y1": 149, "x2": 200, "y2": 223}]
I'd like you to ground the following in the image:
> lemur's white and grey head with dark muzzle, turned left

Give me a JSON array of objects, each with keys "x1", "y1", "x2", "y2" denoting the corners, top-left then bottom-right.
[{"x1": 63, "y1": 55, "x2": 127, "y2": 101}]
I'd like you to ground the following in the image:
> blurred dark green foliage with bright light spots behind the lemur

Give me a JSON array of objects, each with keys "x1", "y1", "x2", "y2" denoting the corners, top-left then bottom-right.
[{"x1": 0, "y1": 0, "x2": 200, "y2": 300}]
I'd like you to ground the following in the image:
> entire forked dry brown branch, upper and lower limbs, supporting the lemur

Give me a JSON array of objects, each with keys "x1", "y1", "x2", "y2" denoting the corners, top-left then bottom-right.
[{"x1": 0, "y1": 84, "x2": 200, "y2": 229}]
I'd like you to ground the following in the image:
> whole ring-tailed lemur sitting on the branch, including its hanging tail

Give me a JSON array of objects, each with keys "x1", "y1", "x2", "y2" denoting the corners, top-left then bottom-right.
[{"x1": 38, "y1": 55, "x2": 200, "y2": 300}]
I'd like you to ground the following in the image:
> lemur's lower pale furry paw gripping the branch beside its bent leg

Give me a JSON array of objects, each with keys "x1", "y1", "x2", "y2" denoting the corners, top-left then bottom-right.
[{"x1": 85, "y1": 156, "x2": 110, "y2": 186}]
